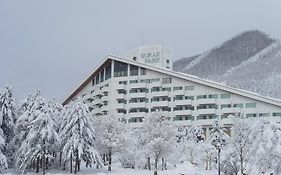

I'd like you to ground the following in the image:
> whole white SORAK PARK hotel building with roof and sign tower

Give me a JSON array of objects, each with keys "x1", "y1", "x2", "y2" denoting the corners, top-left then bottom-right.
[{"x1": 63, "y1": 45, "x2": 281, "y2": 135}]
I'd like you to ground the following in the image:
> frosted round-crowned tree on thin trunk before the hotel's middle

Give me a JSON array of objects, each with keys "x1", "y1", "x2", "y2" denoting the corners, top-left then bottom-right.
[{"x1": 142, "y1": 112, "x2": 176, "y2": 175}]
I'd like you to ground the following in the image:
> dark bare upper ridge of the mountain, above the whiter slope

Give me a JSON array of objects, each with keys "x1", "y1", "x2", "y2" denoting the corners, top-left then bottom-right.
[{"x1": 174, "y1": 30, "x2": 275, "y2": 80}]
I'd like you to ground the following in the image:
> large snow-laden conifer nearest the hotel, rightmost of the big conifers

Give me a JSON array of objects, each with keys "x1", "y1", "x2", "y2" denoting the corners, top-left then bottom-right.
[{"x1": 60, "y1": 99, "x2": 101, "y2": 173}]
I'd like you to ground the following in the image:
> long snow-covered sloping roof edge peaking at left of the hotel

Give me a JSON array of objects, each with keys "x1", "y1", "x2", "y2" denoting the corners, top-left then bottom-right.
[{"x1": 63, "y1": 55, "x2": 281, "y2": 107}]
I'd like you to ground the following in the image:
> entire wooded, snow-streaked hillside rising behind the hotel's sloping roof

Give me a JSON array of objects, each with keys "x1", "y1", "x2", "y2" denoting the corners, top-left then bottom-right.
[{"x1": 173, "y1": 30, "x2": 281, "y2": 99}]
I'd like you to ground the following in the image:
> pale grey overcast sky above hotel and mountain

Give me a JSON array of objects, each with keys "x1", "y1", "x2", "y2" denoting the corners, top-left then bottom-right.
[{"x1": 0, "y1": 0, "x2": 281, "y2": 101}]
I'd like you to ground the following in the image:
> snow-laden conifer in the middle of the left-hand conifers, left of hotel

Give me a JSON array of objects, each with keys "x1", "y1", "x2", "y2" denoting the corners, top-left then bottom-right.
[{"x1": 15, "y1": 95, "x2": 59, "y2": 174}]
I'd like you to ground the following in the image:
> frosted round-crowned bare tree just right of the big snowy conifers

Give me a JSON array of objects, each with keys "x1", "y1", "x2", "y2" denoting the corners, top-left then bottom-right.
[{"x1": 95, "y1": 115, "x2": 125, "y2": 171}]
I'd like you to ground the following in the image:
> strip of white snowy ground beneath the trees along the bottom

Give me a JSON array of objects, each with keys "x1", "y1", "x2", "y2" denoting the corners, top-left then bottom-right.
[{"x1": 4, "y1": 164, "x2": 217, "y2": 175}]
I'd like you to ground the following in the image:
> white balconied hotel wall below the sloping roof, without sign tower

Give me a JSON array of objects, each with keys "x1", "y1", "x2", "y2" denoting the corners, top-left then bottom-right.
[{"x1": 67, "y1": 58, "x2": 281, "y2": 135}]
